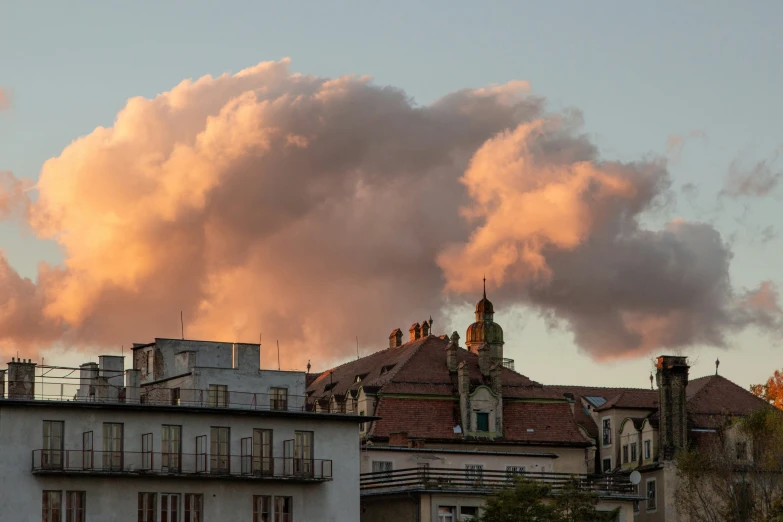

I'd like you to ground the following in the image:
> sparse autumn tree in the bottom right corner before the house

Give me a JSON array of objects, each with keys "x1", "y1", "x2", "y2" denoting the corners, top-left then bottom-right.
[{"x1": 675, "y1": 408, "x2": 783, "y2": 522}]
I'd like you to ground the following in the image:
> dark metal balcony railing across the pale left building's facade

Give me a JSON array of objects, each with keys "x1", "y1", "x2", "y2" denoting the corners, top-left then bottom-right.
[{"x1": 32, "y1": 450, "x2": 332, "y2": 482}]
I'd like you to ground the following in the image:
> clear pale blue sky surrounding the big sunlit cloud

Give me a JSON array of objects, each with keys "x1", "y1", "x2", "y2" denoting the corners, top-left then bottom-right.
[{"x1": 0, "y1": 0, "x2": 783, "y2": 386}]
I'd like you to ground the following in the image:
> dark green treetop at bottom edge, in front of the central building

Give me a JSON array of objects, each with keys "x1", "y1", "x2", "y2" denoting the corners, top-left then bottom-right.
[{"x1": 479, "y1": 477, "x2": 617, "y2": 522}]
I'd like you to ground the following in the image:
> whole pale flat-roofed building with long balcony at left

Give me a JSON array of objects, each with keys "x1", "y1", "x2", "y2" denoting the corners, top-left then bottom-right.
[{"x1": 0, "y1": 339, "x2": 366, "y2": 522}]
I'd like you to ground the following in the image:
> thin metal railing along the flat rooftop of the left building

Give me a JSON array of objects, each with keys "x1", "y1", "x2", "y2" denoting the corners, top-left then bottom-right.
[{"x1": 0, "y1": 381, "x2": 310, "y2": 412}]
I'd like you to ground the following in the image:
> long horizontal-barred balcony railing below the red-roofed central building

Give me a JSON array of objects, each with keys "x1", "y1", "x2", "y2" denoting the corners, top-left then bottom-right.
[{"x1": 360, "y1": 468, "x2": 634, "y2": 497}]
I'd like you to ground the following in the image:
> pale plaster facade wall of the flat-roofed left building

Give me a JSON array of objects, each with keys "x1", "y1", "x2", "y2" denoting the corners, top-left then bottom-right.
[{"x1": 0, "y1": 401, "x2": 360, "y2": 522}]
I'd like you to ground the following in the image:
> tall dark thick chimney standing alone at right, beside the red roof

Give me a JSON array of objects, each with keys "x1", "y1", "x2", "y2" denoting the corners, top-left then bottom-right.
[{"x1": 656, "y1": 355, "x2": 689, "y2": 461}]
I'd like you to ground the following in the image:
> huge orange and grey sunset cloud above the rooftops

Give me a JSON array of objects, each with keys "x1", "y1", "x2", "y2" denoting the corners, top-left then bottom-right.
[{"x1": 0, "y1": 60, "x2": 779, "y2": 367}]
